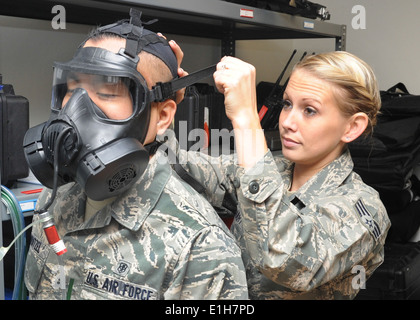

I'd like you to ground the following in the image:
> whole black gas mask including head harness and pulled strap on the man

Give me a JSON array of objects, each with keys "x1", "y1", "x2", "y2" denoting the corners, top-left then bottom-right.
[{"x1": 24, "y1": 10, "x2": 215, "y2": 200}]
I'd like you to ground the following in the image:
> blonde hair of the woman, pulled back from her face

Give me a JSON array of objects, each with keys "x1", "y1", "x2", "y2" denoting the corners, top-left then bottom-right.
[{"x1": 293, "y1": 51, "x2": 381, "y2": 135}]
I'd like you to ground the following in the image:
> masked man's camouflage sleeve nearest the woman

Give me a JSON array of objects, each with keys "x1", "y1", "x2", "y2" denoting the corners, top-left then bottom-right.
[{"x1": 165, "y1": 226, "x2": 248, "y2": 300}]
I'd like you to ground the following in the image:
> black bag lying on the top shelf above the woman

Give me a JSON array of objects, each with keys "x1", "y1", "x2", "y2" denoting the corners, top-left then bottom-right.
[{"x1": 226, "y1": 0, "x2": 331, "y2": 20}]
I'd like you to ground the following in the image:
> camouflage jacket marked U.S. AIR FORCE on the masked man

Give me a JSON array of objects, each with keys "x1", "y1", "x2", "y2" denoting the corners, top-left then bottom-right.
[{"x1": 25, "y1": 150, "x2": 248, "y2": 300}]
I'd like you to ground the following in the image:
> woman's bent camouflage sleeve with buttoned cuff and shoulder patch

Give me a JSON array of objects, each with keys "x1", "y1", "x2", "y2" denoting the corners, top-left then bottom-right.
[{"x1": 238, "y1": 152, "x2": 389, "y2": 291}]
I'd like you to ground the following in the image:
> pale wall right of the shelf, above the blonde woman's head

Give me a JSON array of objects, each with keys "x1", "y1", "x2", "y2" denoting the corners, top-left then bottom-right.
[{"x1": 319, "y1": 0, "x2": 420, "y2": 94}]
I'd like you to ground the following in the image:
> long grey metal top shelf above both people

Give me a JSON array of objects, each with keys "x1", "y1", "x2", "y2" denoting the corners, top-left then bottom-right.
[{"x1": 0, "y1": 0, "x2": 346, "y2": 50}]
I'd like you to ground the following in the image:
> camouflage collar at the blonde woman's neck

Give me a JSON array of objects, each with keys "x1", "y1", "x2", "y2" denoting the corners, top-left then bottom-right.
[{"x1": 286, "y1": 149, "x2": 354, "y2": 206}]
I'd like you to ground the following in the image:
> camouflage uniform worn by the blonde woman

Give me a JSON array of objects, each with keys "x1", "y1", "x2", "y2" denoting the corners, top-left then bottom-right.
[{"x1": 168, "y1": 135, "x2": 390, "y2": 299}]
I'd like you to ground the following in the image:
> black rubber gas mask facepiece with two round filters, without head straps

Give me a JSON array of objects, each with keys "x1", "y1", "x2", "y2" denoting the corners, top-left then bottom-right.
[{"x1": 24, "y1": 48, "x2": 150, "y2": 200}]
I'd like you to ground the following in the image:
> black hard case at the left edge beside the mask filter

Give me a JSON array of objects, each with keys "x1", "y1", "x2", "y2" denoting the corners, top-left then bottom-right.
[{"x1": 0, "y1": 74, "x2": 29, "y2": 187}]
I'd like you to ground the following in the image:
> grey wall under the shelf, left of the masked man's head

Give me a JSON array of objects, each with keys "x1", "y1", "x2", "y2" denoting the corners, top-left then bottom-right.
[{"x1": 0, "y1": 16, "x2": 91, "y2": 126}]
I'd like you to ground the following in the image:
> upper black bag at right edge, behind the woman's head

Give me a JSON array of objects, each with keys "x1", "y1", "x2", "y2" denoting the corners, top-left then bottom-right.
[{"x1": 349, "y1": 84, "x2": 420, "y2": 192}]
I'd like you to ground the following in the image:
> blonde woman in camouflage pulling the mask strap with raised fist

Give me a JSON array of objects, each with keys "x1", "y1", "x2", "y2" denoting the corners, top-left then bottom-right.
[{"x1": 167, "y1": 44, "x2": 390, "y2": 299}]
